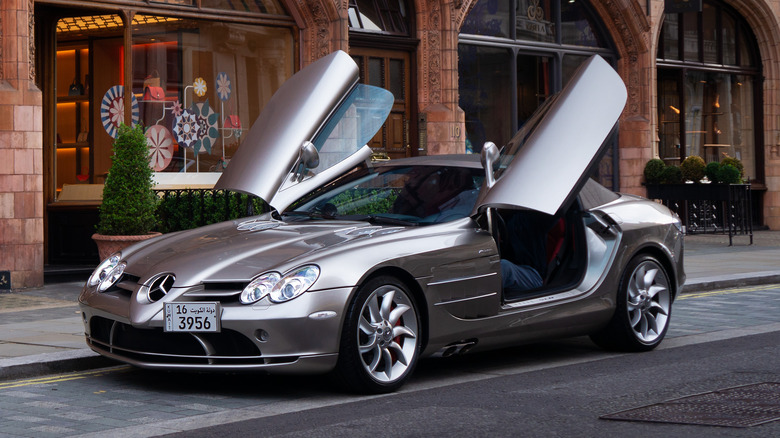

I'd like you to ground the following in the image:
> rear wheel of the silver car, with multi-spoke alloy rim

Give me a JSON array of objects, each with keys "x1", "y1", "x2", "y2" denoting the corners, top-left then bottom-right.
[{"x1": 591, "y1": 255, "x2": 672, "y2": 351}]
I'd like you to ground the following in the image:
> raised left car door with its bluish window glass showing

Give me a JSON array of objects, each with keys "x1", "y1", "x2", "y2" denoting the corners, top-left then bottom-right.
[{"x1": 214, "y1": 51, "x2": 393, "y2": 211}]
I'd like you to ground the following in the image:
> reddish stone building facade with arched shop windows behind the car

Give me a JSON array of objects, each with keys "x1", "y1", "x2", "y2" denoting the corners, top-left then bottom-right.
[{"x1": 0, "y1": 0, "x2": 780, "y2": 289}]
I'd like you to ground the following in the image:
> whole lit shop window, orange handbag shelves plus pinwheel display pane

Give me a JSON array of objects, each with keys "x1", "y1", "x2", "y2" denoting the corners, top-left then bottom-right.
[{"x1": 53, "y1": 7, "x2": 294, "y2": 193}]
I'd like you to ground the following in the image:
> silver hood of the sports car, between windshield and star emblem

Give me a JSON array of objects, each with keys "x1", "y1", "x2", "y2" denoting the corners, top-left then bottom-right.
[{"x1": 123, "y1": 218, "x2": 400, "y2": 287}]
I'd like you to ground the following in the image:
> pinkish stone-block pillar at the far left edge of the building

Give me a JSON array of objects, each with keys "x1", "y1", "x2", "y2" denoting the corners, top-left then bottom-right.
[{"x1": 0, "y1": 0, "x2": 43, "y2": 289}]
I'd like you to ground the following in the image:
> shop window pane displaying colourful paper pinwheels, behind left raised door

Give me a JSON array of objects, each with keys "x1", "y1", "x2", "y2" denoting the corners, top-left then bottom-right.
[{"x1": 132, "y1": 15, "x2": 292, "y2": 176}]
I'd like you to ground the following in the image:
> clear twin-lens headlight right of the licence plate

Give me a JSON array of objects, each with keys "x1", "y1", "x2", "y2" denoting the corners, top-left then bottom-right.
[{"x1": 241, "y1": 265, "x2": 320, "y2": 304}]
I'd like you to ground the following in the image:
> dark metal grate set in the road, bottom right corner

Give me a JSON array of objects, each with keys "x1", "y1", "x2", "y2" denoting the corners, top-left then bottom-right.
[{"x1": 601, "y1": 382, "x2": 780, "y2": 427}]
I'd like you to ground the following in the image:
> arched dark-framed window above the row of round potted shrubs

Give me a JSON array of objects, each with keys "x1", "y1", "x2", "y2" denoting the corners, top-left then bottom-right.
[{"x1": 658, "y1": 2, "x2": 763, "y2": 181}]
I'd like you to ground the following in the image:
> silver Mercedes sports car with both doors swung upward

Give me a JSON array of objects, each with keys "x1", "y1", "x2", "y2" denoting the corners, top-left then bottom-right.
[{"x1": 79, "y1": 52, "x2": 685, "y2": 392}]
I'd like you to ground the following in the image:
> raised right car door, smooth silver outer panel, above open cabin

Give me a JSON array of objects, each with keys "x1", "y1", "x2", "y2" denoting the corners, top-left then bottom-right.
[{"x1": 473, "y1": 56, "x2": 627, "y2": 214}]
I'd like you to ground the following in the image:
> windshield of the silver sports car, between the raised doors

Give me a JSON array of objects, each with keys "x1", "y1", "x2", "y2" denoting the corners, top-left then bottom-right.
[{"x1": 285, "y1": 166, "x2": 484, "y2": 225}]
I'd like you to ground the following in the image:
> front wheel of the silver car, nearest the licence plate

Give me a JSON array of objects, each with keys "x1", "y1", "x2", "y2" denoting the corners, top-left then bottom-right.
[{"x1": 336, "y1": 276, "x2": 422, "y2": 394}]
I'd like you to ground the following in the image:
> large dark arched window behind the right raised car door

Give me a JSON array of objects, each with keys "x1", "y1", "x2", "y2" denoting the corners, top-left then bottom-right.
[{"x1": 458, "y1": 0, "x2": 617, "y2": 187}]
